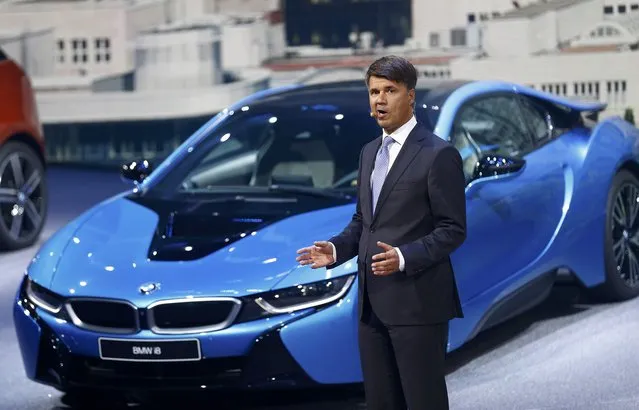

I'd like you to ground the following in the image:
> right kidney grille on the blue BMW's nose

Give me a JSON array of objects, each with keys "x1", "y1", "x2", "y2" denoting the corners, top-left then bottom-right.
[{"x1": 147, "y1": 298, "x2": 241, "y2": 334}]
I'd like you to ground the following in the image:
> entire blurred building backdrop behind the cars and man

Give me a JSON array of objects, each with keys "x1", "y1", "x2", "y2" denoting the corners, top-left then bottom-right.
[{"x1": 0, "y1": 0, "x2": 639, "y2": 162}]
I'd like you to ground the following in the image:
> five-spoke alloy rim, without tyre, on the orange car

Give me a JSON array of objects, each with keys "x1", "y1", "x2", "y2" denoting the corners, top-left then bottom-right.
[{"x1": 0, "y1": 152, "x2": 45, "y2": 242}]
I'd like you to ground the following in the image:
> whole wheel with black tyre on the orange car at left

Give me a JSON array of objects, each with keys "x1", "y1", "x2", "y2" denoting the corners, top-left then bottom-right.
[{"x1": 0, "y1": 141, "x2": 48, "y2": 250}]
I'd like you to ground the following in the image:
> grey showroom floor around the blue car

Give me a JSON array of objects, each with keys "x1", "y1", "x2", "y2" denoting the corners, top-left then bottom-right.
[{"x1": 0, "y1": 167, "x2": 639, "y2": 410}]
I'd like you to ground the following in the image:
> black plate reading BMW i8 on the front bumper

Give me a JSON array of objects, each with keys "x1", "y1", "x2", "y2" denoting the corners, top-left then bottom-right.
[{"x1": 98, "y1": 337, "x2": 202, "y2": 362}]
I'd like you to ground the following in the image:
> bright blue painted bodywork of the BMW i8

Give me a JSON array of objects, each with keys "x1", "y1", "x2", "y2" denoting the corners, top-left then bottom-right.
[{"x1": 14, "y1": 77, "x2": 639, "y2": 390}]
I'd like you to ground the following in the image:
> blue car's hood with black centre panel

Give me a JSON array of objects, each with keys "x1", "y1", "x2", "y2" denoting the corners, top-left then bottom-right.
[{"x1": 40, "y1": 192, "x2": 354, "y2": 305}]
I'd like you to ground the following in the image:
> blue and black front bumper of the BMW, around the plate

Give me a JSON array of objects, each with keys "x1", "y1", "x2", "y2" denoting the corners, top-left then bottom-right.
[{"x1": 14, "y1": 278, "x2": 361, "y2": 391}]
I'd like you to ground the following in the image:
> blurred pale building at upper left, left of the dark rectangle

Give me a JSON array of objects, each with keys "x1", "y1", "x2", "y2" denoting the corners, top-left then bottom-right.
[{"x1": 0, "y1": 0, "x2": 285, "y2": 164}]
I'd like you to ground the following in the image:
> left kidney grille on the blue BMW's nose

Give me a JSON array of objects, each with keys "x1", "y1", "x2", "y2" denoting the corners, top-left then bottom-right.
[{"x1": 67, "y1": 299, "x2": 140, "y2": 333}]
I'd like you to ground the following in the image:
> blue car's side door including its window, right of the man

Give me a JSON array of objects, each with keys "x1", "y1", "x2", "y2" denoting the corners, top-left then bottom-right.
[{"x1": 451, "y1": 93, "x2": 564, "y2": 302}]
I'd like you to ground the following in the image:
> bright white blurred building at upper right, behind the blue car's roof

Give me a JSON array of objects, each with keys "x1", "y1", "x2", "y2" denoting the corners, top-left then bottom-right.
[{"x1": 450, "y1": 0, "x2": 639, "y2": 115}]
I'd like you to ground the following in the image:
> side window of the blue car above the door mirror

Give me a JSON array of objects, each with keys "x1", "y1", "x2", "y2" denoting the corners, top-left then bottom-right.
[{"x1": 453, "y1": 95, "x2": 533, "y2": 157}]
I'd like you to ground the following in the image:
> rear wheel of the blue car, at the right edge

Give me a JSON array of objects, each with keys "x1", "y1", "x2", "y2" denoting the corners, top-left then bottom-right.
[{"x1": 601, "y1": 170, "x2": 639, "y2": 300}]
